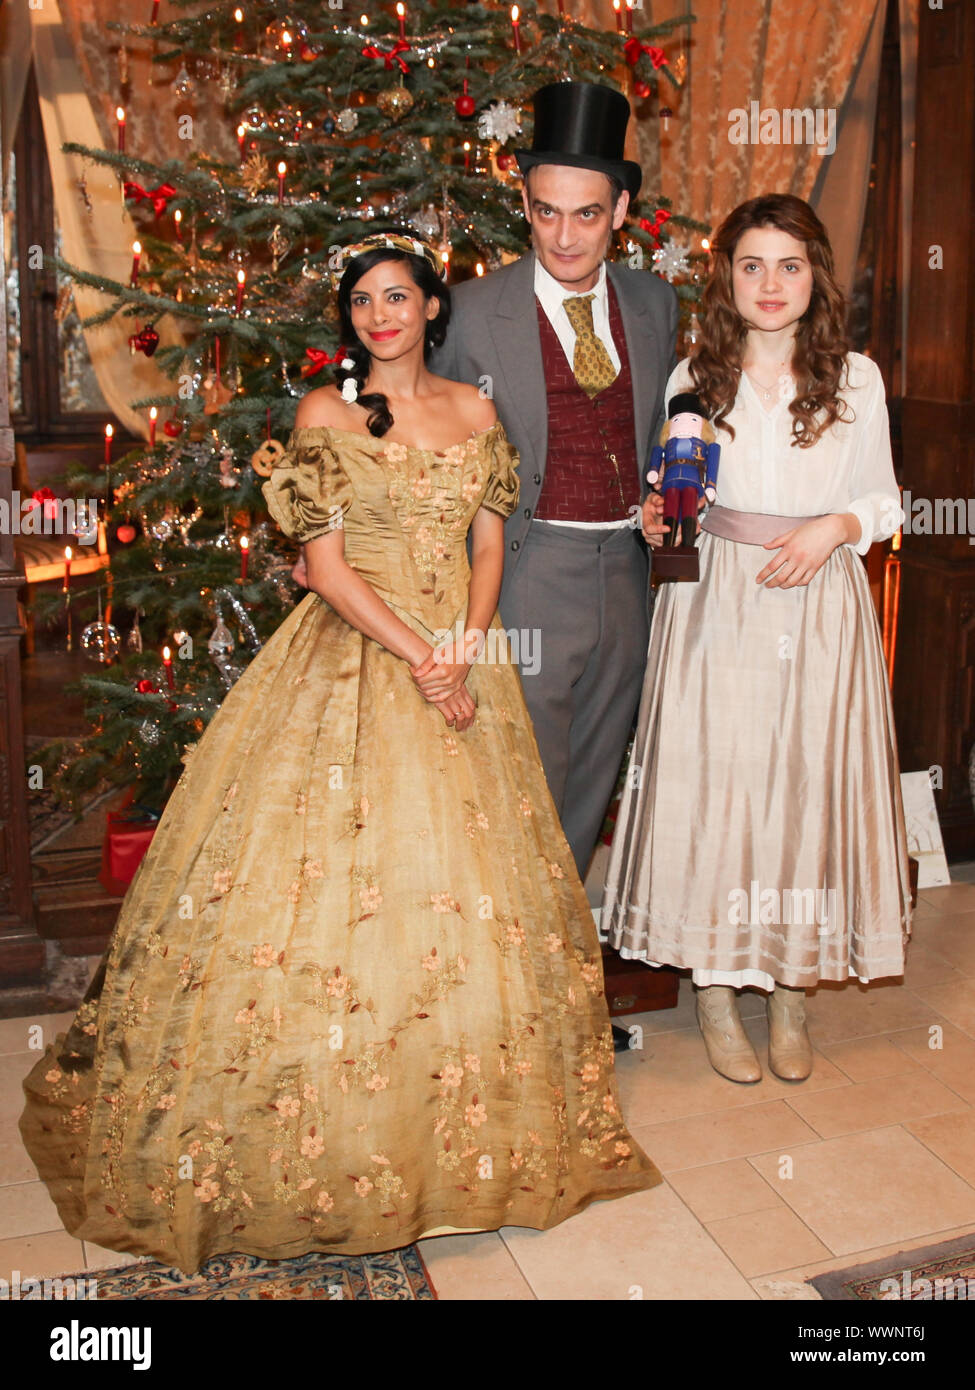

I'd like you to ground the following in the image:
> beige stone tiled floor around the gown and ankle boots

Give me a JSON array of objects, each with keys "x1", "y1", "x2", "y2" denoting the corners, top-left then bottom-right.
[{"x1": 0, "y1": 876, "x2": 975, "y2": 1300}]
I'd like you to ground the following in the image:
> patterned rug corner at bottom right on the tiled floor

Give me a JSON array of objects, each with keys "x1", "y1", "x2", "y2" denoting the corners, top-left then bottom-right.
[{"x1": 808, "y1": 1236, "x2": 975, "y2": 1302}]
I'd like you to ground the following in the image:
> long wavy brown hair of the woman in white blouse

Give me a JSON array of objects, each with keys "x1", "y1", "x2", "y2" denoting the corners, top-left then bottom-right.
[{"x1": 690, "y1": 193, "x2": 853, "y2": 449}]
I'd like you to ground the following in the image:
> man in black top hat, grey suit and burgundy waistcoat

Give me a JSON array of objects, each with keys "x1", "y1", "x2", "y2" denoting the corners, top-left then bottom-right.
[{"x1": 430, "y1": 82, "x2": 677, "y2": 877}]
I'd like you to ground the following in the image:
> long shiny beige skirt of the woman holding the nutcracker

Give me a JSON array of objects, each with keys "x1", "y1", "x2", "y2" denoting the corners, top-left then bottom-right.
[{"x1": 602, "y1": 534, "x2": 911, "y2": 988}]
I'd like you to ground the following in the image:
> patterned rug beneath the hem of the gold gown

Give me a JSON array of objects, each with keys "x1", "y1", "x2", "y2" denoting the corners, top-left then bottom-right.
[{"x1": 61, "y1": 1245, "x2": 437, "y2": 1302}]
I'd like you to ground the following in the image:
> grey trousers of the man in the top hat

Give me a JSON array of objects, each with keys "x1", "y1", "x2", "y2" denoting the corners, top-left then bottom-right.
[{"x1": 501, "y1": 521, "x2": 650, "y2": 878}]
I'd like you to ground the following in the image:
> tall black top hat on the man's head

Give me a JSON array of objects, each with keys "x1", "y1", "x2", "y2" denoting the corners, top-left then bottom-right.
[{"x1": 515, "y1": 82, "x2": 643, "y2": 199}]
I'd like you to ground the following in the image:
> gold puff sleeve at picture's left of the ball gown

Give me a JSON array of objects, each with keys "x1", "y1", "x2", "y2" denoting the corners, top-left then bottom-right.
[{"x1": 261, "y1": 428, "x2": 353, "y2": 545}]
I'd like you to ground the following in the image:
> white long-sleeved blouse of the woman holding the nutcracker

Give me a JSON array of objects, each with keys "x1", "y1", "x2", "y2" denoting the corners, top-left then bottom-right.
[{"x1": 666, "y1": 352, "x2": 904, "y2": 555}]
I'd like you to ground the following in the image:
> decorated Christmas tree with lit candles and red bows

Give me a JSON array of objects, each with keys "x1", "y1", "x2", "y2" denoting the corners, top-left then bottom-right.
[{"x1": 41, "y1": 0, "x2": 707, "y2": 809}]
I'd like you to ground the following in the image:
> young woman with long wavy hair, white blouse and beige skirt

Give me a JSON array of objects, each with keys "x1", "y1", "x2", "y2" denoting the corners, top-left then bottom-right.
[{"x1": 602, "y1": 195, "x2": 911, "y2": 1081}]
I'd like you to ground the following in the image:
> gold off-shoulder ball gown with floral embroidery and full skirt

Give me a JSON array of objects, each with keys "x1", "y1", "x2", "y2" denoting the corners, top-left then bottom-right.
[{"x1": 21, "y1": 414, "x2": 661, "y2": 1270}]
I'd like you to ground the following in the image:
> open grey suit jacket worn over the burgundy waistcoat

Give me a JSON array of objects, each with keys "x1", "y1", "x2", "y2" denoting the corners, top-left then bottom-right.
[{"x1": 430, "y1": 252, "x2": 677, "y2": 585}]
